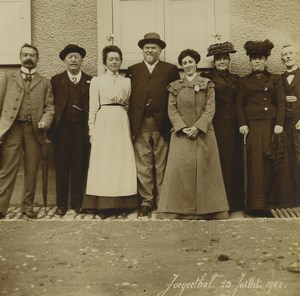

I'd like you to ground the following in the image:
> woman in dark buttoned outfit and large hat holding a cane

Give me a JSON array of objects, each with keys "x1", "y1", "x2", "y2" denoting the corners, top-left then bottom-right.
[{"x1": 236, "y1": 40, "x2": 290, "y2": 215}]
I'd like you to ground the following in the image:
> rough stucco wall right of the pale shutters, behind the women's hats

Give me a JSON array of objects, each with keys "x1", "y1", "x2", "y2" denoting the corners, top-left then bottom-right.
[{"x1": 230, "y1": 0, "x2": 300, "y2": 75}]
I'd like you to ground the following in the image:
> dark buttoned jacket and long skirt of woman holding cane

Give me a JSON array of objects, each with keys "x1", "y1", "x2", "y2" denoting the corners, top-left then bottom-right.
[{"x1": 236, "y1": 71, "x2": 286, "y2": 210}]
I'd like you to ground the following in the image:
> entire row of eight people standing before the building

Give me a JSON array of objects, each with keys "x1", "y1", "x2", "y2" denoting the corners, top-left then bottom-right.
[{"x1": 0, "y1": 33, "x2": 300, "y2": 219}]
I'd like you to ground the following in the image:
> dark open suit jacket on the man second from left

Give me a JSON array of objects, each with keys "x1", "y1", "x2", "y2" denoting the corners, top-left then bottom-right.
[{"x1": 49, "y1": 71, "x2": 92, "y2": 139}]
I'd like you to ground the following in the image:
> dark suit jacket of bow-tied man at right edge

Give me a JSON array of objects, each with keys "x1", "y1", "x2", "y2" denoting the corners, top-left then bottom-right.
[{"x1": 281, "y1": 68, "x2": 300, "y2": 124}]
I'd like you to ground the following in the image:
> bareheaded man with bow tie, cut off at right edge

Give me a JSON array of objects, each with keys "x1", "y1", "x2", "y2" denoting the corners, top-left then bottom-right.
[{"x1": 281, "y1": 45, "x2": 300, "y2": 201}]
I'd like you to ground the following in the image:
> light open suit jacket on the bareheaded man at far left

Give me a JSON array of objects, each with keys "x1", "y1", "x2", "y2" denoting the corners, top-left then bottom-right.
[{"x1": 0, "y1": 71, "x2": 54, "y2": 143}]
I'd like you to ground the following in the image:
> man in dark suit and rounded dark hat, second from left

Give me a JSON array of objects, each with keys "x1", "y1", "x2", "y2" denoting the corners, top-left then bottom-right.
[{"x1": 49, "y1": 44, "x2": 92, "y2": 216}]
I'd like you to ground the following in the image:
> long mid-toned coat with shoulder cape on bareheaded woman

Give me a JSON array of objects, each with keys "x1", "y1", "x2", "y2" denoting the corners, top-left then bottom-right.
[{"x1": 158, "y1": 76, "x2": 228, "y2": 215}]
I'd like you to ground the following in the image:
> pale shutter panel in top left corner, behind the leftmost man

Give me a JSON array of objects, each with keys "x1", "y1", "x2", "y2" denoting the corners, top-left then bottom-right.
[{"x1": 0, "y1": 0, "x2": 31, "y2": 65}]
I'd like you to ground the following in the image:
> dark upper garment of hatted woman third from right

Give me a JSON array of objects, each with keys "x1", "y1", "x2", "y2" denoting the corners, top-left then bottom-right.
[{"x1": 200, "y1": 69, "x2": 239, "y2": 120}]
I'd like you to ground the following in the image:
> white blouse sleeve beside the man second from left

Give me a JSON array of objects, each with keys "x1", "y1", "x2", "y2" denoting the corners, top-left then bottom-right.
[{"x1": 88, "y1": 77, "x2": 101, "y2": 136}]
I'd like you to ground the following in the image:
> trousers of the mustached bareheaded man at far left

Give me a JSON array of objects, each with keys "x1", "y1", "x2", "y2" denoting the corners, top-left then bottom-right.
[{"x1": 0, "y1": 121, "x2": 42, "y2": 215}]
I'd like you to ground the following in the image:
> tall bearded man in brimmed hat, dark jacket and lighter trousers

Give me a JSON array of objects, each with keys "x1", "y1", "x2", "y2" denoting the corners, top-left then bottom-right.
[{"x1": 126, "y1": 33, "x2": 180, "y2": 217}]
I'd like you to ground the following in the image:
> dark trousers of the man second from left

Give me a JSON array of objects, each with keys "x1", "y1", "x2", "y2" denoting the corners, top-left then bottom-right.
[{"x1": 53, "y1": 121, "x2": 89, "y2": 209}]
